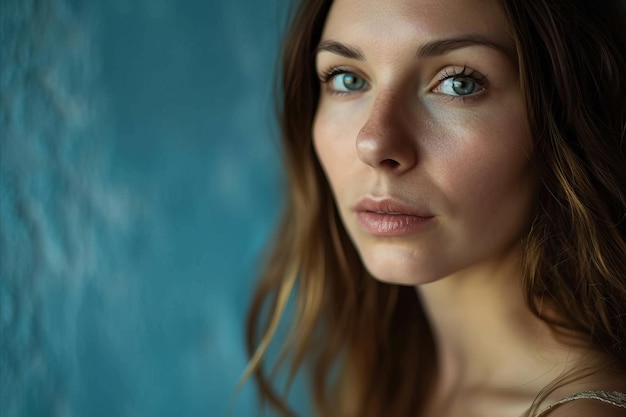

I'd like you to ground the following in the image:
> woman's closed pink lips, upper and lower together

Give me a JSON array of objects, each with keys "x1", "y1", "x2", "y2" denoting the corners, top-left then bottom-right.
[{"x1": 354, "y1": 197, "x2": 435, "y2": 237}]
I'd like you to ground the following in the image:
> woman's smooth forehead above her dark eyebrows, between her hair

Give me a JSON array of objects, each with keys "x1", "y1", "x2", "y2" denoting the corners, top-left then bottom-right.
[{"x1": 322, "y1": 0, "x2": 513, "y2": 48}]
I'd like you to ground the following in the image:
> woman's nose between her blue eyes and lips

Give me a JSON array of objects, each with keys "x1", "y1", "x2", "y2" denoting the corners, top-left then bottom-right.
[{"x1": 356, "y1": 92, "x2": 418, "y2": 174}]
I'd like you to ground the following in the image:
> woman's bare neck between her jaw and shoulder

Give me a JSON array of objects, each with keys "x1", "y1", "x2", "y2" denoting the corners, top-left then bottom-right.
[{"x1": 418, "y1": 250, "x2": 580, "y2": 404}]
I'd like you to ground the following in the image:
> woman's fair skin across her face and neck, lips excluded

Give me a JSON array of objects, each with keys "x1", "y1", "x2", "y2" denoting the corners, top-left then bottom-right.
[{"x1": 313, "y1": 0, "x2": 610, "y2": 417}]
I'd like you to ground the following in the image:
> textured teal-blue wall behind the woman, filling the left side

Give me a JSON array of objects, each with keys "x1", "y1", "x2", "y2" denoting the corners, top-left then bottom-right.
[{"x1": 0, "y1": 0, "x2": 288, "y2": 417}]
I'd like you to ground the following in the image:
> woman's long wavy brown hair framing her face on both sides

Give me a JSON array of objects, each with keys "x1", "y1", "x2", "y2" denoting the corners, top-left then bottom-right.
[{"x1": 246, "y1": 0, "x2": 626, "y2": 417}]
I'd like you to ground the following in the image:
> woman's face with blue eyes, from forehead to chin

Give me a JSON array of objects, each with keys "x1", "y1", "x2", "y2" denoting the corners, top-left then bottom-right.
[{"x1": 313, "y1": 0, "x2": 536, "y2": 284}]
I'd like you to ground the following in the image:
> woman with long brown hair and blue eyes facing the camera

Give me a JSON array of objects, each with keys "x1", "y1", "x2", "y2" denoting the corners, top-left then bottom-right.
[{"x1": 243, "y1": 0, "x2": 626, "y2": 417}]
